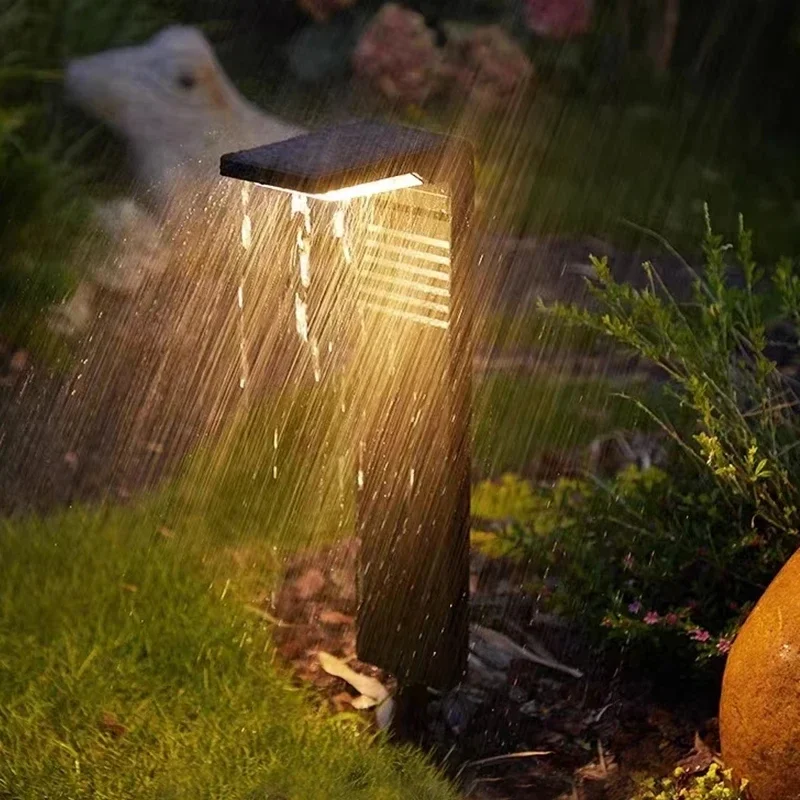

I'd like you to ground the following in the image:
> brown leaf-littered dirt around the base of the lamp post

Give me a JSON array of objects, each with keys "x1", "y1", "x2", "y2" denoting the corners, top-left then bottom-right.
[{"x1": 262, "y1": 540, "x2": 718, "y2": 800}]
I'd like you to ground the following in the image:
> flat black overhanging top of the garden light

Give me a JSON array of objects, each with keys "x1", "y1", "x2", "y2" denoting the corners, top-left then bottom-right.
[{"x1": 220, "y1": 122, "x2": 456, "y2": 194}]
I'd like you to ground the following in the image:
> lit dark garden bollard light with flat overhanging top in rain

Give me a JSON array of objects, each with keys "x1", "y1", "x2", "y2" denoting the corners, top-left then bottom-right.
[{"x1": 220, "y1": 122, "x2": 474, "y2": 690}]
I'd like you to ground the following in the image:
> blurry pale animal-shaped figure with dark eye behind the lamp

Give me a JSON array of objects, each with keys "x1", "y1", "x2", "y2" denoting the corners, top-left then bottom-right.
[{"x1": 66, "y1": 26, "x2": 303, "y2": 206}]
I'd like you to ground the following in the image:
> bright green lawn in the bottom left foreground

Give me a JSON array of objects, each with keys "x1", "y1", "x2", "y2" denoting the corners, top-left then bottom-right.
[{"x1": 0, "y1": 509, "x2": 456, "y2": 800}]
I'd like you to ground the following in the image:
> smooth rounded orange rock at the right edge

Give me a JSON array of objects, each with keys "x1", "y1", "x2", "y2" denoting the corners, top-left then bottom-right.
[{"x1": 720, "y1": 552, "x2": 800, "y2": 800}]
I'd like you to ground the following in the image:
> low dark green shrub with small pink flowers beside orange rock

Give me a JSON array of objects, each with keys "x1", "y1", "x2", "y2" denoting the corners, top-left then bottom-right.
[{"x1": 473, "y1": 467, "x2": 764, "y2": 661}]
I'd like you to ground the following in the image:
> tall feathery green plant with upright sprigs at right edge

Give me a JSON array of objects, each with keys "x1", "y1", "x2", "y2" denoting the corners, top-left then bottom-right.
[{"x1": 551, "y1": 209, "x2": 800, "y2": 550}]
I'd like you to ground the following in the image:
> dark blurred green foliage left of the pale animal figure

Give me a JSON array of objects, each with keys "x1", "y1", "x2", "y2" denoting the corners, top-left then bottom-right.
[{"x1": 0, "y1": 0, "x2": 173, "y2": 344}]
